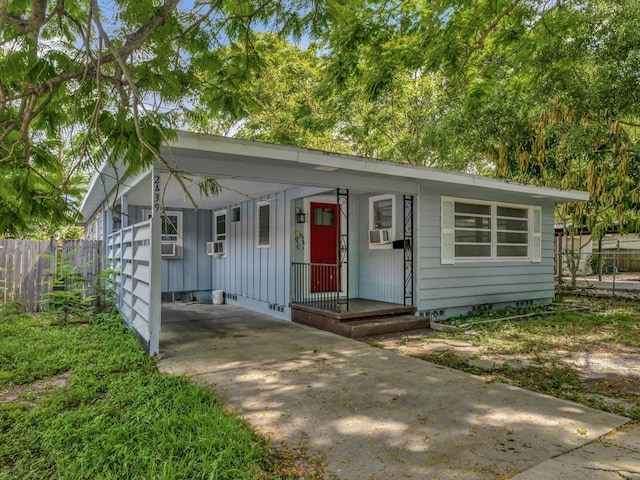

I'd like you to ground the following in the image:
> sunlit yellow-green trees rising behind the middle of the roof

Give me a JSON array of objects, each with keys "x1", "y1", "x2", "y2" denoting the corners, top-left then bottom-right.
[{"x1": 192, "y1": 33, "x2": 482, "y2": 169}]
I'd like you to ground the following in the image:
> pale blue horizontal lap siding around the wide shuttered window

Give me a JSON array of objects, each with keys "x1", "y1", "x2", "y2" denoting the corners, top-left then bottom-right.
[{"x1": 415, "y1": 184, "x2": 554, "y2": 317}]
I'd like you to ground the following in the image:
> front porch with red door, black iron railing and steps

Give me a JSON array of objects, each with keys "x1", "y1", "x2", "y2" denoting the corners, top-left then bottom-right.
[{"x1": 289, "y1": 189, "x2": 420, "y2": 338}]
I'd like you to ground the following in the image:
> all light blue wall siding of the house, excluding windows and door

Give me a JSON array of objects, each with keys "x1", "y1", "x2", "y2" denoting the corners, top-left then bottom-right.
[{"x1": 129, "y1": 178, "x2": 554, "y2": 318}]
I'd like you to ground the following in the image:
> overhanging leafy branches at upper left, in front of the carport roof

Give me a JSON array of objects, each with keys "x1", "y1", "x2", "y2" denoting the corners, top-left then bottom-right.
[{"x1": 0, "y1": 0, "x2": 326, "y2": 234}]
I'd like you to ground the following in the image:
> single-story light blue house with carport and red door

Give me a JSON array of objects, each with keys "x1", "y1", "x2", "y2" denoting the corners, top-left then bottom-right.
[{"x1": 81, "y1": 132, "x2": 588, "y2": 354}]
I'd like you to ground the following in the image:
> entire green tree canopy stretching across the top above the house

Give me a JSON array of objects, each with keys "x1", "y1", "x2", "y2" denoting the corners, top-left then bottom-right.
[{"x1": 0, "y1": 0, "x2": 640, "y2": 235}]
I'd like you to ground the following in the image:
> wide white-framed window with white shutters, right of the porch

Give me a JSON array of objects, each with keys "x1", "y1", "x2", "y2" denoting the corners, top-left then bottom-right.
[{"x1": 441, "y1": 197, "x2": 542, "y2": 264}]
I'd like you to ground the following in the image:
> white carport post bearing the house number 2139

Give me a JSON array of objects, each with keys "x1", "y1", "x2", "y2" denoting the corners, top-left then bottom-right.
[{"x1": 149, "y1": 168, "x2": 162, "y2": 357}]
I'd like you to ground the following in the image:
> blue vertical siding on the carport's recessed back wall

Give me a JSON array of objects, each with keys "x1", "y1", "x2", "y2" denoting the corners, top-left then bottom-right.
[{"x1": 129, "y1": 206, "x2": 213, "y2": 293}]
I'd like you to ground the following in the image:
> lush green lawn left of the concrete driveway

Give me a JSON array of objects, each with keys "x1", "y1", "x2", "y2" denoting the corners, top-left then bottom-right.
[{"x1": 0, "y1": 308, "x2": 277, "y2": 479}]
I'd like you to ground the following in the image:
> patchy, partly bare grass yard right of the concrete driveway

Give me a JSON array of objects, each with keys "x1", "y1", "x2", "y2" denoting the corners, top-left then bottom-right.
[{"x1": 420, "y1": 300, "x2": 640, "y2": 421}]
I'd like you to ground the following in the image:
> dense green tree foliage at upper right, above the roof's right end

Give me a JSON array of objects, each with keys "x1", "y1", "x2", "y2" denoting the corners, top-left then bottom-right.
[{"x1": 316, "y1": 0, "x2": 640, "y2": 237}]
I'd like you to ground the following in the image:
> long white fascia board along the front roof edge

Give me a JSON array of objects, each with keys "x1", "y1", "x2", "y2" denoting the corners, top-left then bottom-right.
[{"x1": 169, "y1": 132, "x2": 589, "y2": 203}]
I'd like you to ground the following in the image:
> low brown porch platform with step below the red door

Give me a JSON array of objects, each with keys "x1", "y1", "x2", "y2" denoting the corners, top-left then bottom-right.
[{"x1": 289, "y1": 298, "x2": 429, "y2": 338}]
